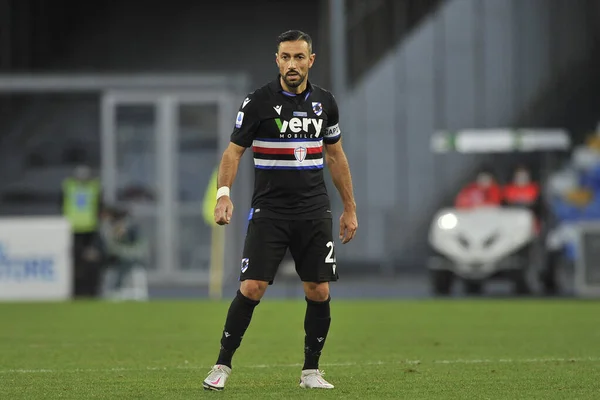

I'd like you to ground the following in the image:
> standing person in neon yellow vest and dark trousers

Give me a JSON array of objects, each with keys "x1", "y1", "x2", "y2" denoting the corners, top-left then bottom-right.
[{"x1": 61, "y1": 165, "x2": 103, "y2": 297}]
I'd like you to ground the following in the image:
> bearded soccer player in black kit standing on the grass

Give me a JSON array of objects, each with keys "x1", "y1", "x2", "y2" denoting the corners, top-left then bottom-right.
[{"x1": 203, "y1": 31, "x2": 358, "y2": 390}]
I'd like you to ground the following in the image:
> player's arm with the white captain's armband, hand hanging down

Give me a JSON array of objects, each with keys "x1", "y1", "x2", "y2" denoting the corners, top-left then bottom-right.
[{"x1": 323, "y1": 93, "x2": 358, "y2": 243}]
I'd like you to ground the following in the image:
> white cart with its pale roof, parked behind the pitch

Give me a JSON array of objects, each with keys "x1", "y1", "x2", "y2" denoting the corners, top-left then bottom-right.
[{"x1": 427, "y1": 130, "x2": 570, "y2": 295}]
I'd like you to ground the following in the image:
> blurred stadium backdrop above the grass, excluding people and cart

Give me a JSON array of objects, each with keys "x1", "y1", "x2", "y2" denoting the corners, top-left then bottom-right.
[{"x1": 0, "y1": 0, "x2": 600, "y2": 299}]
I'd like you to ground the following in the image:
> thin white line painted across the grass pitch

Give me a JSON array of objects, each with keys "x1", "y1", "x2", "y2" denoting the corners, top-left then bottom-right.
[{"x1": 0, "y1": 357, "x2": 600, "y2": 375}]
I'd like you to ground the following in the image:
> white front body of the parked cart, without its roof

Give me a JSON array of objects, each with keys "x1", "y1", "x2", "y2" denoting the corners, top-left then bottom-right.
[{"x1": 429, "y1": 207, "x2": 537, "y2": 294}]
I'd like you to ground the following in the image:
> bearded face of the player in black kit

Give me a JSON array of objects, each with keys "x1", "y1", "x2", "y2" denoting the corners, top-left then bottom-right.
[{"x1": 275, "y1": 40, "x2": 315, "y2": 88}]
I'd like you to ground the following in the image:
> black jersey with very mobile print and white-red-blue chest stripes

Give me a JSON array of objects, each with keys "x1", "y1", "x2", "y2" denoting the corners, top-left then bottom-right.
[{"x1": 231, "y1": 77, "x2": 341, "y2": 219}]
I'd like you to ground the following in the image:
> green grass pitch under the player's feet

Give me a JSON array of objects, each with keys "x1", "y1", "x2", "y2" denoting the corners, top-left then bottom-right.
[{"x1": 0, "y1": 298, "x2": 600, "y2": 400}]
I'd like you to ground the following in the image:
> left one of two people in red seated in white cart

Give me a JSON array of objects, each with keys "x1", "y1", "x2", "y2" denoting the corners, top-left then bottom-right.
[{"x1": 455, "y1": 169, "x2": 502, "y2": 208}]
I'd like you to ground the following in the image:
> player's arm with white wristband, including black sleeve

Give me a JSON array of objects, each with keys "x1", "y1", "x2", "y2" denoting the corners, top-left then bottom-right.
[{"x1": 215, "y1": 94, "x2": 260, "y2": 225}]
